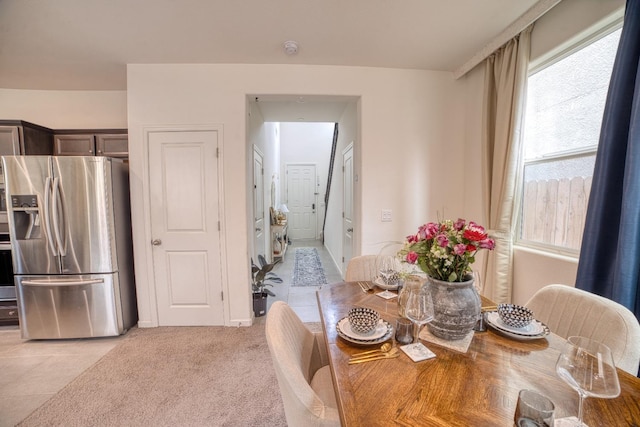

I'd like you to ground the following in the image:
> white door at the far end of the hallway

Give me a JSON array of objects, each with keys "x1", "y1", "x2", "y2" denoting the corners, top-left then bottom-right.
[{"x1": 287, "y1": 164, "x2": 317, "y2": 239}]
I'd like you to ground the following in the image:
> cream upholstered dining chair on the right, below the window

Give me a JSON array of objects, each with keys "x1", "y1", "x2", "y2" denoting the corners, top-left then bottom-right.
[{"x1": 525, "y1": 285, "x2": 640, "y2": 375}]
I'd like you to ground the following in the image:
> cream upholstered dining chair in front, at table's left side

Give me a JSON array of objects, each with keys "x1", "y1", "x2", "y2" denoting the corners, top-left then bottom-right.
[{"x1": 265, "y1": 301, "x2": 340, "y2": 427}]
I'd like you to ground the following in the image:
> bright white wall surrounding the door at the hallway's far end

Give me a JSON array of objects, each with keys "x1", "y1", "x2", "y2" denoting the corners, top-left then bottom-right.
[{"x1": 280, "y1": 122, "x2": 335, "y2": 239}]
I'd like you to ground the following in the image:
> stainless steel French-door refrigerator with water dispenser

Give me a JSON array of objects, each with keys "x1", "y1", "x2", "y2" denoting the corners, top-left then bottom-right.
[{"x1": 2, "y1": 156, "x2": 137, "y2": 339}]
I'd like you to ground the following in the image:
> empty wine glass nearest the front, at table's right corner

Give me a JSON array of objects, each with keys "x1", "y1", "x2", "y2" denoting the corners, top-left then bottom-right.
[{"x1": 556, "y1": 337, "x2": 620, "y2": 426}]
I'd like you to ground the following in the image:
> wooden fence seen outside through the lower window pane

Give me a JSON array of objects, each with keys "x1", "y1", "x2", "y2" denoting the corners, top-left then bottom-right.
[{"x1": 522, "y1": 177, "x2": 591, "y2": 250}]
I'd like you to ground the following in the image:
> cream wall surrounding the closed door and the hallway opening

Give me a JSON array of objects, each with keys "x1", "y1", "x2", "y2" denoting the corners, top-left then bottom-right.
[{"x1": 127, "y1": 64, "x2": 465, "y2": 326}]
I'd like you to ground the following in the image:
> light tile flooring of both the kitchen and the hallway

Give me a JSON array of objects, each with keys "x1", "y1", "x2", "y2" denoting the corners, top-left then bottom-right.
[{"x1": 0, "y1": 241, "x2": 342, "y2": 427}]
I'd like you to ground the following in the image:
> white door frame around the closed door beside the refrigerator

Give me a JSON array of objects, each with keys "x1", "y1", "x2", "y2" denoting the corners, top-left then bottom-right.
[{"x1": 141, "y1": 124, "x2": 230, "y2": 327}]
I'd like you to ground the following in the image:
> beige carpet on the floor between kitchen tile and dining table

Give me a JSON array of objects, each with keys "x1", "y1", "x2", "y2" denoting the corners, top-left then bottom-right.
[{"x1": 19, "y1": 324, "x2": 287, "y2": 427}]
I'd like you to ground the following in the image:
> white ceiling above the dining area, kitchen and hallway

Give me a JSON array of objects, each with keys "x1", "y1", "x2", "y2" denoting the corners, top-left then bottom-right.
[{"x1": 0, "y1": 0, "x2": 538, "y2": 121}]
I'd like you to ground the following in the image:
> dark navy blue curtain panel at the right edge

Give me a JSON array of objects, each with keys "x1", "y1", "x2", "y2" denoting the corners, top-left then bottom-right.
[{"x1": 576, "y1": 0, "x2": 640, "y2": 319}]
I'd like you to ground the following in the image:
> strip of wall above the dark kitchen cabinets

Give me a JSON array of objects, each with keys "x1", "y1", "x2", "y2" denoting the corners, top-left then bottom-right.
[{"x1": 0, "y1": 89, "x2": 127, "y2": 129}]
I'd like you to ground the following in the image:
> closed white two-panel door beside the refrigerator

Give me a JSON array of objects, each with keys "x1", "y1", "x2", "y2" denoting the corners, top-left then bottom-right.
[{"x1": 149, "y1": 131, "x2": 224, "y2": 326}]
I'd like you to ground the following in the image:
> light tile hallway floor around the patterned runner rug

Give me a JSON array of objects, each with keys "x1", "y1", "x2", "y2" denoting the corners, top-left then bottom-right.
[{"x1": 266, "y1": 240, "x2": 342, "y2": 322}]
